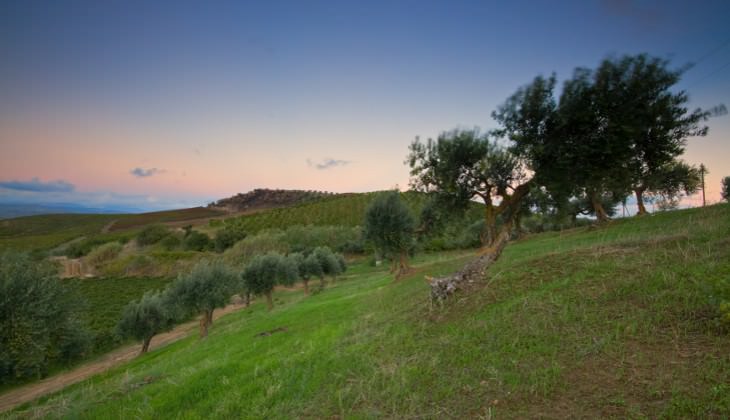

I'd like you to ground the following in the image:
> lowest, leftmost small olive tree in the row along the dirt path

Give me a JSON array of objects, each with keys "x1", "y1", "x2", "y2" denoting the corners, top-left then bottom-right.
[{"x1": 117, "y1": 292, "x2": 175, "y2": 354}]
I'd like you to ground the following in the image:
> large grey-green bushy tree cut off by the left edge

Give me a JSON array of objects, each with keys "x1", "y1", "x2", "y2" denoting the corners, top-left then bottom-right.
[{"x1": 0, "y1": 252, "x2": 90, "y2": 382}]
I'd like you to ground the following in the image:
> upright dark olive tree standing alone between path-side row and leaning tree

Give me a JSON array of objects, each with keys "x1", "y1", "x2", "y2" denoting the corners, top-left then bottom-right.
[{"x1": 363, "y1": 191, "x2": 415, "y2": 278}]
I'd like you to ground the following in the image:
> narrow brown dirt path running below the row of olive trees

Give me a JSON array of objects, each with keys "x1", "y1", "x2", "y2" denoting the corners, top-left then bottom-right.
[{"x1": 0, "y1": 304, "x2": 244, "y2": 413}]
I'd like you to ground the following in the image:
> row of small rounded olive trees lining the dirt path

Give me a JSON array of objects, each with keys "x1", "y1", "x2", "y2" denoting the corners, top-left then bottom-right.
[{"x1": 117, "y1": 247, "x2": 347, "y2": 353}]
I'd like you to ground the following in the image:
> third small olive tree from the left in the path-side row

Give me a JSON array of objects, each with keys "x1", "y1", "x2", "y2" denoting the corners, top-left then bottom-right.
[{"x1": 241, "y1": 253, "x2": 299, "y2": 310}]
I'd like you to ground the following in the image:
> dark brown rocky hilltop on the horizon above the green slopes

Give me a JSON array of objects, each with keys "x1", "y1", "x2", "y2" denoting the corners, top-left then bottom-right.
[{"x1": 208, "y1": 188, "x2": 339, "y2": 213}]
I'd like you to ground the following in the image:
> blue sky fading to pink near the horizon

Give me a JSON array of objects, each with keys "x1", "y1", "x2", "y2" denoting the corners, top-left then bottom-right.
[{"x1": 0, "y1": 0, "x2": 730, "y2": 210}]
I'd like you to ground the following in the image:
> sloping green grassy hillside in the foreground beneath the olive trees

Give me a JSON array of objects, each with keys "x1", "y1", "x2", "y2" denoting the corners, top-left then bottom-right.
[{"x1": 8, "y1": 205, "x2": 730, "y2": 418}]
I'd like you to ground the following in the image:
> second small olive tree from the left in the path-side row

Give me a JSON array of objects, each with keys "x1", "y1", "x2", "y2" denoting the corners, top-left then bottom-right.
[{"x1": 169, "y1": 261, "x2": 236, "y2": 338}]
